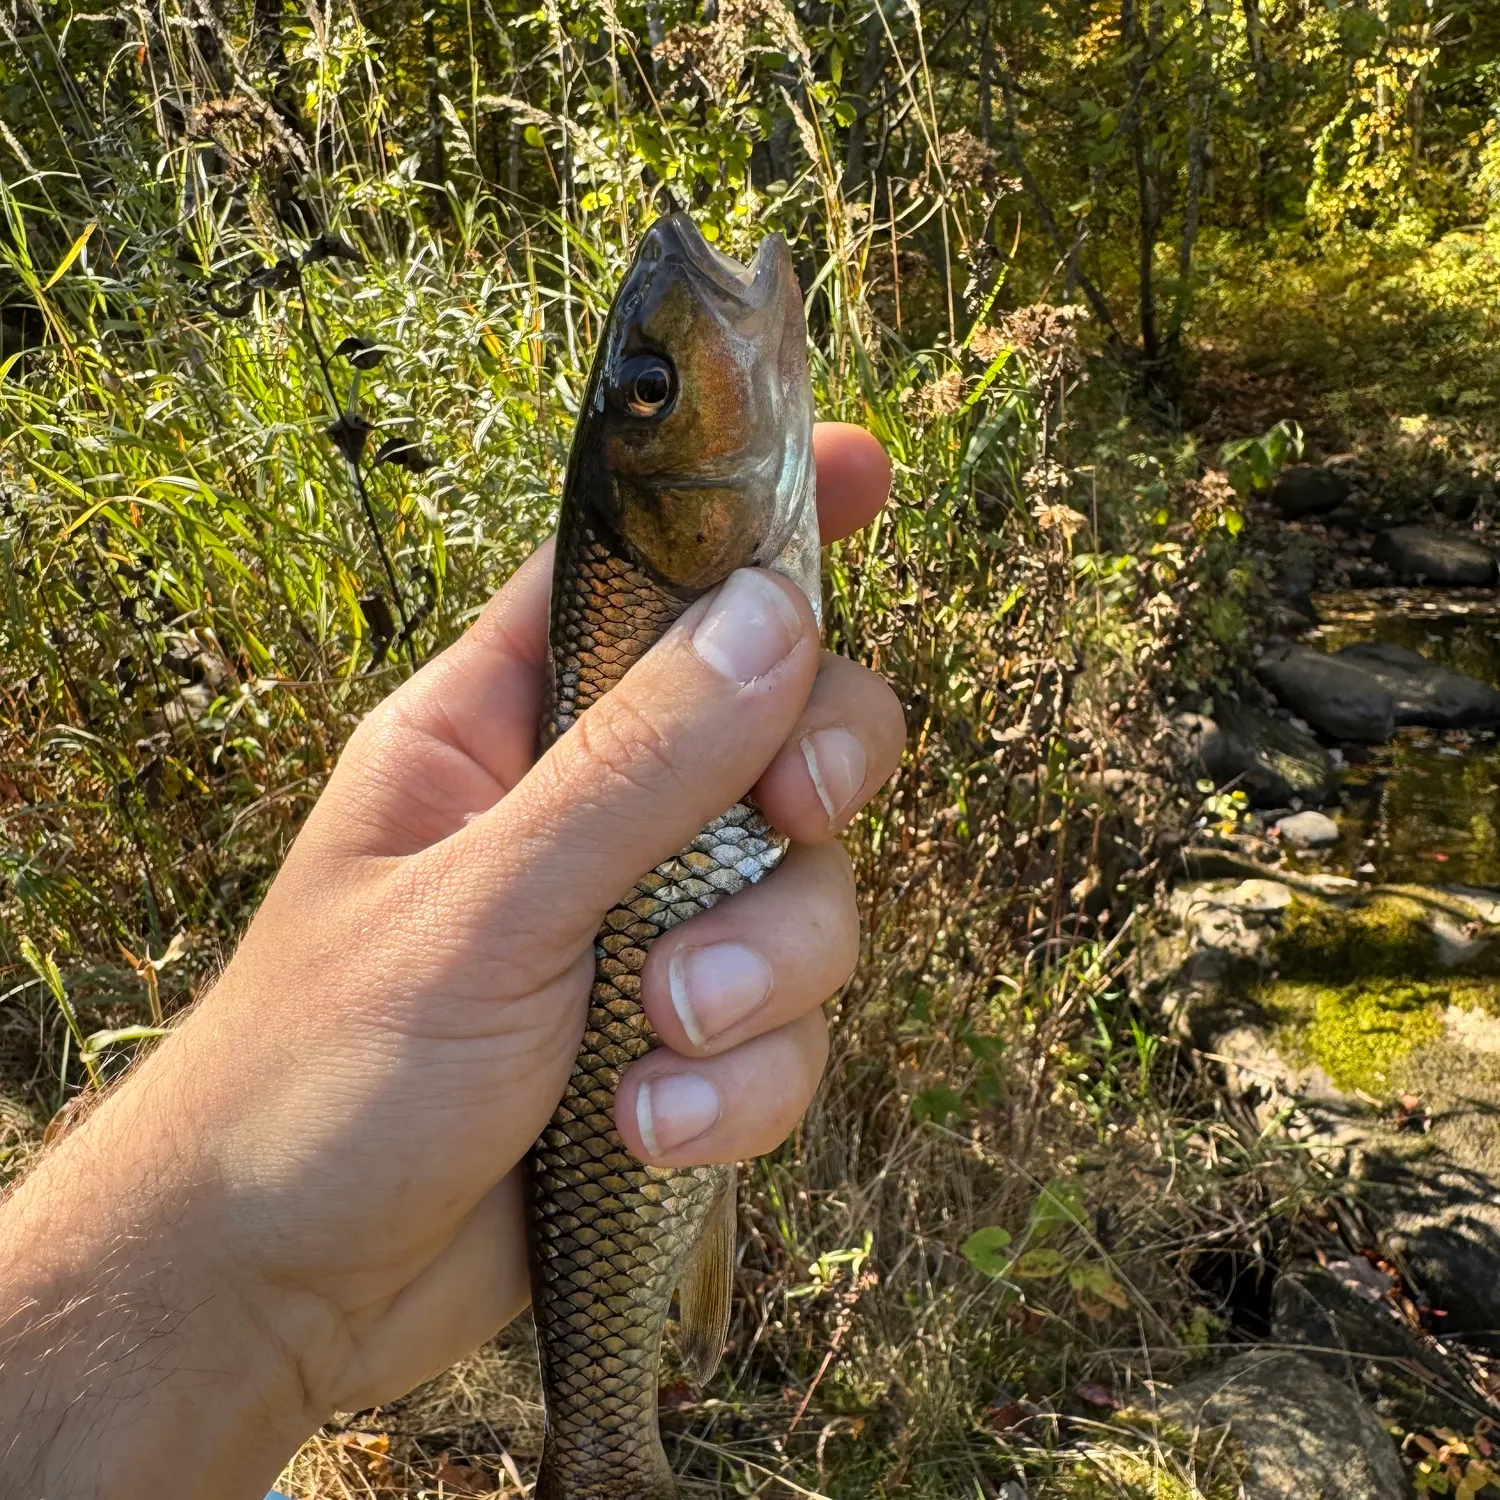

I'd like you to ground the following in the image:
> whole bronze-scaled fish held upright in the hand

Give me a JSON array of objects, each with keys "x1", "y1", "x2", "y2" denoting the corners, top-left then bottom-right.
[{"x1": 527, "y1": 213, "x2": 821, "y2": 1500}]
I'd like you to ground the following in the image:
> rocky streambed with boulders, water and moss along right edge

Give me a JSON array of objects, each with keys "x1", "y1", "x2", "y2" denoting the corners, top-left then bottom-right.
[{"x1": 1148, "y1": 467, "x2": 1500, "y2": 1500}]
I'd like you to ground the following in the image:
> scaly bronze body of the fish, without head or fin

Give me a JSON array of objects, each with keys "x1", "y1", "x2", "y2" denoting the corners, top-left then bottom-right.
[{"x1": 530, "y1": 522, "x2": 786, "y2": 1500}]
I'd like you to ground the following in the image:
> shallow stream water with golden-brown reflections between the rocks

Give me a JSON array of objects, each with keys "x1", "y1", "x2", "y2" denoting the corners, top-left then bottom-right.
[{"x1": 1307, "y1": 588, "x2": 1500, "y2": 887}]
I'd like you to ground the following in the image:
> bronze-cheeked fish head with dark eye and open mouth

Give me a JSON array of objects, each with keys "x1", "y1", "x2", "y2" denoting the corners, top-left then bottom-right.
[{"x1": 569, "y1": 213, "x2": 816, "y2": 599}]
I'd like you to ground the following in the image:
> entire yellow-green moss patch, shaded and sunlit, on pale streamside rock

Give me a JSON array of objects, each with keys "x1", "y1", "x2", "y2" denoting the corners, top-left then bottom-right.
[{"x1": 1257, "y1": 893, "x2": 1500, "y2": 1095}]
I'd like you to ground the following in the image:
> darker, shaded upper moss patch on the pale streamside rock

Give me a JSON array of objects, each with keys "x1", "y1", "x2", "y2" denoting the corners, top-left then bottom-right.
[{"x1": 1274, "y1": 896, "x2": 1437, "y2": 986}]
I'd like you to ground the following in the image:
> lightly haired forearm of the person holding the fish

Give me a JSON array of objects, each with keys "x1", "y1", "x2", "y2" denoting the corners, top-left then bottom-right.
[{"x1": 0, "y1": 1059, "x2": 317, "y2": 1500}]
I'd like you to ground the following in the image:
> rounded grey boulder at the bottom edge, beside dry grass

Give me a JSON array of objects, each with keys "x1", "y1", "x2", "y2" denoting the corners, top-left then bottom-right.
[{"x1": 1161, "y1": 1352, "x2": 1409, "y2": 1500}]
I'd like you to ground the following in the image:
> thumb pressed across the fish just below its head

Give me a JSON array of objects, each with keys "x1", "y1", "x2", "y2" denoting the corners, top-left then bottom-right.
[{"x1": 432, "y1": 569, "x2": 819, "y2": 962}]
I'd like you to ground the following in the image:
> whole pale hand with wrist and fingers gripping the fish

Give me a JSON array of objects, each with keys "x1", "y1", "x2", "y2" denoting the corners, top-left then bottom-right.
[{"x1": 0, "y1": 423, "x2": 903, "y2": 1500}]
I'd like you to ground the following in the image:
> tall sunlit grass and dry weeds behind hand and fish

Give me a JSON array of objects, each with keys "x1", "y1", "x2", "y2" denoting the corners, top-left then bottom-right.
[{"x1": 0, "y1": 3, "x2": 1314, "y2": 1497}]
